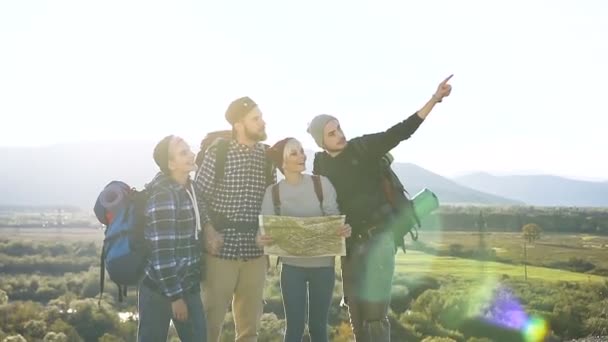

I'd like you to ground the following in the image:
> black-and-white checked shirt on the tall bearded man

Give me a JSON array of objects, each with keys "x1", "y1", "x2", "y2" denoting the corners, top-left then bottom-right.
[{"x1": 195, "y1": 140, "x2": 276, "y2": 260}]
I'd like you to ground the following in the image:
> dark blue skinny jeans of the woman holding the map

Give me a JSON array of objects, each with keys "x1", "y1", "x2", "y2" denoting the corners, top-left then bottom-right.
[{"x1": 281, "y1": 264, "x2": 336, "y2": 342}]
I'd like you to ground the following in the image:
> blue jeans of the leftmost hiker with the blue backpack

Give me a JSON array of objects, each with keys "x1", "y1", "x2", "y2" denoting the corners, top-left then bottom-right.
[{"x1": 137, "y1": 284, "x2": 207, "y2": 342}]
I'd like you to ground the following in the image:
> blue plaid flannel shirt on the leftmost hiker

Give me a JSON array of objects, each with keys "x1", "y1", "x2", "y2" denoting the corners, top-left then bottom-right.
[{"x1": 144, "y1": 173, "x2": 201, "y2": 300}]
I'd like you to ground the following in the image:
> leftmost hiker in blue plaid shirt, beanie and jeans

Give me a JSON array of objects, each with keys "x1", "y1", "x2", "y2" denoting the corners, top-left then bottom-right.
[{"x1": 137, "y1": 135, "x2": 207, "y2": 342}]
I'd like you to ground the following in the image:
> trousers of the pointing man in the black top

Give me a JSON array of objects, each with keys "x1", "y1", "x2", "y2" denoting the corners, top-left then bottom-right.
[{"x1": 342, "y1": 231, "x2": 396, "y2": 342}]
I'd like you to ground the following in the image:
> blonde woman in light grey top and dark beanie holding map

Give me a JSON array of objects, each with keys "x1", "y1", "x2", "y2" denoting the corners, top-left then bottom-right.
[{"x1": 258, "y1": 138, "x2": 351, "y2": 342}]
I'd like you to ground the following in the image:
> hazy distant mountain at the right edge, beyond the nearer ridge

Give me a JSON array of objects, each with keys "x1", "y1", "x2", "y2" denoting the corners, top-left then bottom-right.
[{"x1": 455, "y1": 172, "x2": 608, "y2": 207}]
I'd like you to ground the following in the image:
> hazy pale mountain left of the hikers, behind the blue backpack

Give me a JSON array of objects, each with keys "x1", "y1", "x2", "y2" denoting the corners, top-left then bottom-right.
[{"x1": 0, "y1": 142, "x2": 156, "y2": 208}]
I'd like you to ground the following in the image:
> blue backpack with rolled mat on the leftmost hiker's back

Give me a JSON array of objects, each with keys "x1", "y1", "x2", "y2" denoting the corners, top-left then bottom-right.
[{"x1": 94, "y1": 181, "x2": 148, "y2": 302}]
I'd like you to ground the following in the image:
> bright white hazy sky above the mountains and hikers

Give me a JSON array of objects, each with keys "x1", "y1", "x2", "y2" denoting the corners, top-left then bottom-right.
[{"x1": 0, "y1": 0, "x2": 608, "y2": 180}]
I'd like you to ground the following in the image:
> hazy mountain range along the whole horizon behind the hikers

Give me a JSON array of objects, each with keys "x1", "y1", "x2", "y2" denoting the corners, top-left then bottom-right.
[{"x1": 0, "y1": 141, "x2": 608, "y2": 209}]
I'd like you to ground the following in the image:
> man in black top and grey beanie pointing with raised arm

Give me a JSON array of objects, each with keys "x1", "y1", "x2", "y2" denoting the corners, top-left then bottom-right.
[{"x1": 308, "y1": 76, "x2": 452, "y2": 342}]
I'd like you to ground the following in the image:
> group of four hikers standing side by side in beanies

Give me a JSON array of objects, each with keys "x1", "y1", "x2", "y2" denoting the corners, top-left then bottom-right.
[{"x1": 137, "y1": 76, "x2": 451, "y2": 342}]
